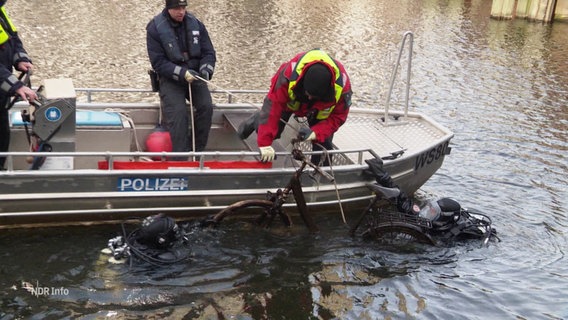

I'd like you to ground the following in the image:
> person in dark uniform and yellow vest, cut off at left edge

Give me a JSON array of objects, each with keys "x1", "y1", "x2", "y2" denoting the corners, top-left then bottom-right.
[{"x1": 0, "y1": 0, "x2": 37, "y2": 170}]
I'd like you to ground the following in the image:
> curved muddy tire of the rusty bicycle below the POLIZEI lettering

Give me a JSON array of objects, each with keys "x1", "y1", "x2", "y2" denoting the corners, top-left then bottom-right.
[{"x1": 208, "y1": 199, "x2": 292, "y2": 226}]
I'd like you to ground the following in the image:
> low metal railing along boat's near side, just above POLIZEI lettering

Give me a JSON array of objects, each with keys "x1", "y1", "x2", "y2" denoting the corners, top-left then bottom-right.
[{"x1": 0, "y1": 149, "x2": 377, "y2": 175}]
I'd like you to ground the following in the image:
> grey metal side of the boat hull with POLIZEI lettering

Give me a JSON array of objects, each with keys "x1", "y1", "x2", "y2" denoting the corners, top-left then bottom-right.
[{"x1": 0, "y1": 146, "x2": 452, "y2": 227}]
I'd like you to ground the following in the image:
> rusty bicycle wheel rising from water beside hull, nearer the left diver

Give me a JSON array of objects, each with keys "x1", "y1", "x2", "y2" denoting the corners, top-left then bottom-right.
[{"x1": 206, "y1": 199, "x2": 292, "y2": 227}]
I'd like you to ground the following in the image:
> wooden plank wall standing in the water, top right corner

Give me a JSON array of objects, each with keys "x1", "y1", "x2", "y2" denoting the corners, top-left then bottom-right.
[{"x1": 491, "y1": 0, "x2": 565, "y2": 23}]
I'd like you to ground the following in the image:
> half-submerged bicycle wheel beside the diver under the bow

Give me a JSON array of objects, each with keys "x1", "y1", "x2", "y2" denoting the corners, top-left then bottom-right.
[{"x1": 363, "y1": 222, "x2": 436, "y2": 245}]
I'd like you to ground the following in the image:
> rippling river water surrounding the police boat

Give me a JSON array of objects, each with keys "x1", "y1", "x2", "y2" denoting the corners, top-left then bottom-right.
[{"x1": 4, "y1": 0, "x2": 568, "y2": 319}]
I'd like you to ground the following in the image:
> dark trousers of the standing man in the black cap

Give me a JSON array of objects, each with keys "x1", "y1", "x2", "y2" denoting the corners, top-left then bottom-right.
[{"x1": 160, "y1": 78, "x2": 213, "y2": 160}]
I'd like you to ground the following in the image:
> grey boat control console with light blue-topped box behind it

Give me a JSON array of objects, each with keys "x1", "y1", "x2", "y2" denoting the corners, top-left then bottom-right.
[{"x1": 10, "y1": 79, "x2": 132, "y2": 170}]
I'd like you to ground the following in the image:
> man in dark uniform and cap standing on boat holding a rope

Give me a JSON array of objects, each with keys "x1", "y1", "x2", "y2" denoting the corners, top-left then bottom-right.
[{"x1": 146, "y1": 0, "x2": 216, "y2": 160}]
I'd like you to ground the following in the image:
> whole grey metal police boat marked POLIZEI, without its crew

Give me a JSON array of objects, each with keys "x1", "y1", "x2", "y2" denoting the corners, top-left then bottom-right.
[{"x1": 0, "y1": 32, "x2": 454, "y2": 228}]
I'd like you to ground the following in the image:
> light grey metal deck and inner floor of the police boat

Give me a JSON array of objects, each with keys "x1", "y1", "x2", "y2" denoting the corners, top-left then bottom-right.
[{"x1": 3, "y1": 99, "x2": 451, "y2": 171}]
